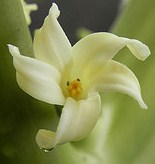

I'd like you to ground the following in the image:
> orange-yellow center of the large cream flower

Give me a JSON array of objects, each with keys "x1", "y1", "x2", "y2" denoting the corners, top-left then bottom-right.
[{"x1": 67, "y1": 79, "x2": 83, "y2": 99}]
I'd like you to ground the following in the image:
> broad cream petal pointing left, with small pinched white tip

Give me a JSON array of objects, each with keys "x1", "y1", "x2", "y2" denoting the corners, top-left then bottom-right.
[{"x1": 8, "y1": 45, "x2": 65, "y2": 105}]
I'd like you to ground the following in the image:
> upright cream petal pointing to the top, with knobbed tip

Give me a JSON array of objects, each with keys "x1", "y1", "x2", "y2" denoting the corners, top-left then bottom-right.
[{"x1": 34, "y1": 3, "x2": 71, "y2": 71}]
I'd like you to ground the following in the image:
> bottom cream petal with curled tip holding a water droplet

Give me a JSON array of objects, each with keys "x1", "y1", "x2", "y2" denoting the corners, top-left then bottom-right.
[{"x1": 36, "y1": 92, "x2": 101, "y2": 149}]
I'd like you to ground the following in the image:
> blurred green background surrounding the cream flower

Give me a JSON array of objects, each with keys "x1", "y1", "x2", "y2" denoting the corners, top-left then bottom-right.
[{"x1": 0, "y1": 0, "x2": 155, "y2": 164}]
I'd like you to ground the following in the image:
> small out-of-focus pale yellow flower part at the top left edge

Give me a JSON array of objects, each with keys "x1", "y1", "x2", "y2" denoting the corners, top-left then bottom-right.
[{"x1": 21, "y1": 0, "x2": 38, "y2": 25}]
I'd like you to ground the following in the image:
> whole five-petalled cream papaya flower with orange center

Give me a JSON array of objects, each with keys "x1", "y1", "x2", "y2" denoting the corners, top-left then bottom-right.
[{"x1": 8, "y1": 3, "x2": 150, "y2": 150}]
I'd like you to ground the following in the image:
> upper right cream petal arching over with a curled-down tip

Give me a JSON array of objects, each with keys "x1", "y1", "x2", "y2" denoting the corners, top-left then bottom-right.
[{"x1": 73, "y1": 32, "x2": 150, "y2": 71}]
